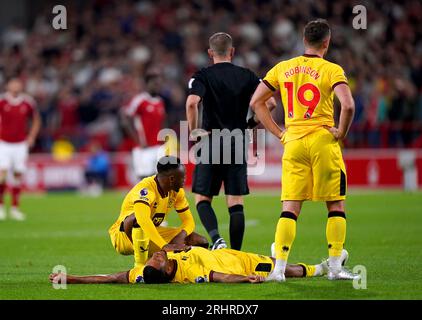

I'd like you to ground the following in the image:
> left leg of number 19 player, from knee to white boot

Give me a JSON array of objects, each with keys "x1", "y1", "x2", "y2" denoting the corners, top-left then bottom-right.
[{"x1": 267, "y1": 200, "x2": 303, "y2": 282}]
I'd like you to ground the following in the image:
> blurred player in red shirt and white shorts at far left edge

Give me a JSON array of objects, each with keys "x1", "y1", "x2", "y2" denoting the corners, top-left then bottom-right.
[{"x1": 0, "y1": 78, "x2": 41, "y2": 221}]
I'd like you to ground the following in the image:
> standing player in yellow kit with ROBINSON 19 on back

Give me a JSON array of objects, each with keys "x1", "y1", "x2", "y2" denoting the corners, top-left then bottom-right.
[{"x1": 251, "y1": 19, "x2": 355, "y2": 281}]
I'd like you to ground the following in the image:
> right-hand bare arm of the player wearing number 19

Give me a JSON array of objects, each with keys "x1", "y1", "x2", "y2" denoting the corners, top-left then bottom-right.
[{"x1": 329, "y1": 83, "x2": 355, "y2": 140}]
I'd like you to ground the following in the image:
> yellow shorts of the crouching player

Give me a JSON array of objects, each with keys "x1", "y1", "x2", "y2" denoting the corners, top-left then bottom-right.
[{"x1": 108, "y1": 220, "x2": 182, "y2": 256}]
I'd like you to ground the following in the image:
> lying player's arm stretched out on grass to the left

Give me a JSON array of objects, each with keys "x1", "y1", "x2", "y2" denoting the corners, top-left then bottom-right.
[{"x1": 48, "y1": 271, "x2": 129, "y2": 284}]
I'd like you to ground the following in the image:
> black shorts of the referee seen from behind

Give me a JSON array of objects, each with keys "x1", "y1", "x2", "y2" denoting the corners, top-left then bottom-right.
[{"x1": 192, "y1": 163, "x2": 249, "y2": 197}]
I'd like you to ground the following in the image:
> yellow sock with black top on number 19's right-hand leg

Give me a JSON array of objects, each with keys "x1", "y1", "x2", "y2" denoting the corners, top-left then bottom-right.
[{"x1": 326, "y1": 211, "x2": 346, "y2": 269}]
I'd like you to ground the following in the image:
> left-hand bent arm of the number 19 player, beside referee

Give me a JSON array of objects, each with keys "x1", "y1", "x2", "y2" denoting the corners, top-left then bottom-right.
[{"x1": 250, "y1": 82, "x2": 283, "y2": 139}]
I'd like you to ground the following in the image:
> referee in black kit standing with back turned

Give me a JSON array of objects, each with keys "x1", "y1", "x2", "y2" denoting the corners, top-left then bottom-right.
[{"x1": 186, "y1": 32, "x2": 276, "y2": 250}]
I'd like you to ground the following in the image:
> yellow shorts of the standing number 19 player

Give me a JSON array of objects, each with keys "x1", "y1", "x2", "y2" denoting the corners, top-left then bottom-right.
[{"x1": 281, "y1": 128, "x2": 346, "y2": 201}]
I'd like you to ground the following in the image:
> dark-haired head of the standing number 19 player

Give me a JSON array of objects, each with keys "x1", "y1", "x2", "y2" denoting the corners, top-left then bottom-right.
[{"x1": 303, "y1": 19, "x2": 331, "y2": 52}]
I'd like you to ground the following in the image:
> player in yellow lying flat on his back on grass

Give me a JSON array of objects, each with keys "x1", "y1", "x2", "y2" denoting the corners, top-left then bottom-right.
[{"x1": 49, "y1": 247, "x2": 348, "y2": 284}]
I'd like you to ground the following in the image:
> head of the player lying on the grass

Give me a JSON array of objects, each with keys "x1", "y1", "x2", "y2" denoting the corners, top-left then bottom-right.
[{"x1": 143, "y1": 251, "x2": 173, "y2": 283}]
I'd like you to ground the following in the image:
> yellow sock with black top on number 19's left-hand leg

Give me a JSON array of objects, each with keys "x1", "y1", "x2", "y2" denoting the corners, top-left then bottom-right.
[{"x1": 274, "y1": 211, "x2": 297, "y2": 273}]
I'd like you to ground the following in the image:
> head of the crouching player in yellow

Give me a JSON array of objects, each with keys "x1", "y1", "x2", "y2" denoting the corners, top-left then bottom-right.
[{"x1": 157, "y1": 156, "x2": 186, "y2": 192}]
